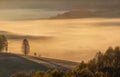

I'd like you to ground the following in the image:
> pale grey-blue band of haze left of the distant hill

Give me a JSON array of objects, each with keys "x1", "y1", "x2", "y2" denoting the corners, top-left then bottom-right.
[{"x1": 0, "y1": 9, "x2": 64, "y2": 20}]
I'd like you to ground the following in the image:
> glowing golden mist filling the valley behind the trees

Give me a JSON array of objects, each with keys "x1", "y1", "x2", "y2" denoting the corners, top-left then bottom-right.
[{"x1": 0, "y1": 18, "x2": 120, "y2": 62}]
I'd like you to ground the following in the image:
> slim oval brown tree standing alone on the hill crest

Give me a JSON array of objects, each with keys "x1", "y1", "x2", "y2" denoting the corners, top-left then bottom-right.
[{"x1": 22, "y1": 39, "x2": 30, "y2": 56}]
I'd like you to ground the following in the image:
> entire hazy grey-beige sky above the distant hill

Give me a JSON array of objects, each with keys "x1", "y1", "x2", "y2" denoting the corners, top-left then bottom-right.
[{"x1": 0, "y1": 0, "x2": 120, "y2": 20}]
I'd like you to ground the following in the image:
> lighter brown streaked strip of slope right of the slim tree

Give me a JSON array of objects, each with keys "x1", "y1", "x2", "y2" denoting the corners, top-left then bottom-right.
[{"x1": 23, "y1": 56, "x2": 79, "y2": 70}]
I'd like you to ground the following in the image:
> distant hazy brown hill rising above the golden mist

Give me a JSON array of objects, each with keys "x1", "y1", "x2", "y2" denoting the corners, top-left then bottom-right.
[{"x1": 50, "y1": 9, "x2": 120, "y2": 19}]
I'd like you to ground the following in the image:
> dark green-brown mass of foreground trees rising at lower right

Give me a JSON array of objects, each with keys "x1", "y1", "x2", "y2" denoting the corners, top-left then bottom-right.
[{"x1": 11, "y1": 47, "x2": 120, "y2": 77}]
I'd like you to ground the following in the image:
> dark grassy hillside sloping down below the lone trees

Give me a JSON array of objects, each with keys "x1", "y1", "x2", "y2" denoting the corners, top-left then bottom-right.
[{"x1": 0, "y1": 53, "x2": 78, "y2": 77}]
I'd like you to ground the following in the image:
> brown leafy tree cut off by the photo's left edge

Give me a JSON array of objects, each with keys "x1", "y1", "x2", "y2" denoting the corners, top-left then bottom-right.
[{"x1": 0, "y1": 35, "x2": 8, "y2": 52}]
